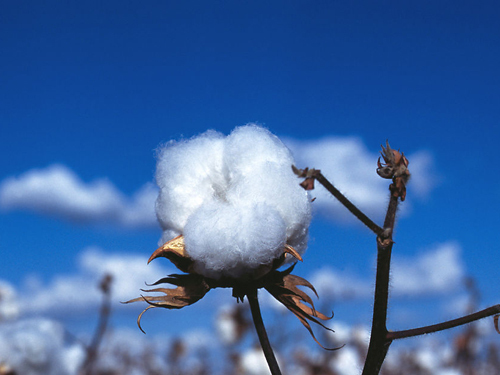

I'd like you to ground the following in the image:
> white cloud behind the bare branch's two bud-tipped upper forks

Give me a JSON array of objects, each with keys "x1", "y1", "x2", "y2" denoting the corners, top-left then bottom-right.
[{"x1": 285, "y1": 137, "x2": 436, "y2": 220}]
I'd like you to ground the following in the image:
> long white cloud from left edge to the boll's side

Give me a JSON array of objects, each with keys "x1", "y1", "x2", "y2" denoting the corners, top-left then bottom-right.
[{"x1": 0, "y1": 164, "x2": 157, "y2": 227}]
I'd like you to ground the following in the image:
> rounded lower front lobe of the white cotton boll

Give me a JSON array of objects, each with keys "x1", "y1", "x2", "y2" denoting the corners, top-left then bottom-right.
[{"x1": 184, "y1": 201, "x2": 286, "y2": 279}]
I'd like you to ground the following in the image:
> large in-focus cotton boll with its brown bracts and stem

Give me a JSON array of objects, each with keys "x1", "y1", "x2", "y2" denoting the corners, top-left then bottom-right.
[{"x1": 129, "y1": 124, "x2": 334, "y2": 373}]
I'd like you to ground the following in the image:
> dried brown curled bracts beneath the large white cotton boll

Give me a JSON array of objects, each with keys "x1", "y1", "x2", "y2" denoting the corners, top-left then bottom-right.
[{"x1": 125, "y1": 235, "x2": 331, "y2": 346}]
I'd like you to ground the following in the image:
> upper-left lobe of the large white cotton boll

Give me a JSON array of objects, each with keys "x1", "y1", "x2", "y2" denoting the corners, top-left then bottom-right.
[{"x1": 156, "y1": 131, "x2": 225, "y2": 240}]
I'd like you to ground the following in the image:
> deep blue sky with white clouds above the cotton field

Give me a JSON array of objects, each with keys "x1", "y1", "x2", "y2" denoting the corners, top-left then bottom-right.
[{"x1": 0, "y1": 1, "x2": 500, "y2": 344}]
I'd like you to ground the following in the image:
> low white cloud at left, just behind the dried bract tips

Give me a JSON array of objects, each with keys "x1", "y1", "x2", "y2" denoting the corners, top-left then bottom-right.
[{"x1": 19, "y1": 248, "x2": 172, "y2": 314}]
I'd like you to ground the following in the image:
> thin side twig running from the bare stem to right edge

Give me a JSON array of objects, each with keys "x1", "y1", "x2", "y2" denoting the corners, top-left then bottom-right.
[{"x1": 386, "y1": 305, "x2": 500, "y2": 341}]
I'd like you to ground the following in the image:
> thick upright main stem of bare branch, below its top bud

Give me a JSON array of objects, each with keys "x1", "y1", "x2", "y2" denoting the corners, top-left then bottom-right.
[{"x1": 362, "y1": 194, "x2": 399, "y2": 375}]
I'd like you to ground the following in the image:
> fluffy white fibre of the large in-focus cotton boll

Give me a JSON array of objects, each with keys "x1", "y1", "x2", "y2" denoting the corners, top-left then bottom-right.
[{"x1": 156, "y1": 125, "x2": 311, "y2": 278}]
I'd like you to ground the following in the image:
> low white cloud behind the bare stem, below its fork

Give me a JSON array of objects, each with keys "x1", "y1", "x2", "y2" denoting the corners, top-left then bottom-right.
[{"x1": 310, "y1": 242, "x2": 465, "y2": 300}]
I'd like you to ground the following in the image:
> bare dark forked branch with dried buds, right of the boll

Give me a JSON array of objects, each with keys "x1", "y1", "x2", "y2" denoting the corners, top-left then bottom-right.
[{"x1": 294, "y1": 141, "x2": 500, "y2": 375}]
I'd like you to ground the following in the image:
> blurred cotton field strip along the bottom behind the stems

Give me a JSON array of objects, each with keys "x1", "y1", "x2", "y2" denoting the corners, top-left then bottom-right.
[{"x1": 0, "y1": 290, "x2": 500, "y2": 375}]
